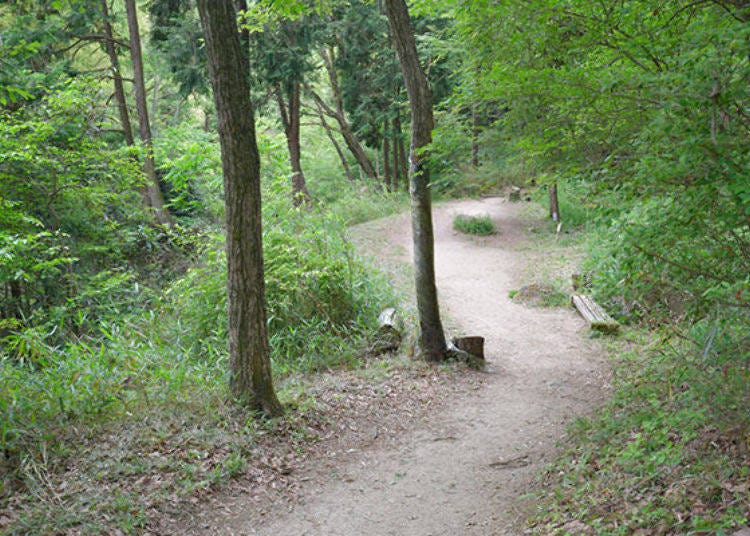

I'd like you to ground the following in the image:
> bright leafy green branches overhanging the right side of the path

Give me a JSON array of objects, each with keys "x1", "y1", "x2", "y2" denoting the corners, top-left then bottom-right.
[{"x1": 451, "y1": 0, "x2": 750, "y2": 319}]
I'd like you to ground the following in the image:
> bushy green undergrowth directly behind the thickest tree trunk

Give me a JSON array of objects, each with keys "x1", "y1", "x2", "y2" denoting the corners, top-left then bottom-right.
[{"x1": 169, "y1": 175, "x2": 400, "y2": 373}]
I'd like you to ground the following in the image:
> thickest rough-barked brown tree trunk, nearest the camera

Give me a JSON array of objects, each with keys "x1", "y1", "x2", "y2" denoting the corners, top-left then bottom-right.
[{"x1": 198, "y1": 0, "x2": 283, "y2": 416}]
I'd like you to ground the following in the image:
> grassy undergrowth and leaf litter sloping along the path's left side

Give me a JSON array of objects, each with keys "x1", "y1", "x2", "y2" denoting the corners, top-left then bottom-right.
[{"x1": 0, "y1": 177, "x2": 397, "y2": 534}]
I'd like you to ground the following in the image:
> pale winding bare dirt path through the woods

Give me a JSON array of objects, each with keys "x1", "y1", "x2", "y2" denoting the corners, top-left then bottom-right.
[{"x1": 212, "y1": 198, "x2": 606, "y2": 536}]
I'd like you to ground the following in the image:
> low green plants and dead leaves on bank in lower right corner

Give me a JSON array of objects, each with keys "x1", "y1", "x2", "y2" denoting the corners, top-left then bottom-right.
[{"x1": 531, "y1": 315, "x2": 750, "y2": 534}]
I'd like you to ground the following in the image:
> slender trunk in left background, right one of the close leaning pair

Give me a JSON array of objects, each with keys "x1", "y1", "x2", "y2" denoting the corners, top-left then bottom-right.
[{"x1": 125, "y1": 0, "x2": 172, "y2": 225}]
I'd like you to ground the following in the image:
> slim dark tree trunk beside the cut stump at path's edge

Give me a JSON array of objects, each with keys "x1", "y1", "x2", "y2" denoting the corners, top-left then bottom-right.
[{"x1": 385, "y1": 0, "x2": 447, "y2": 361}]
